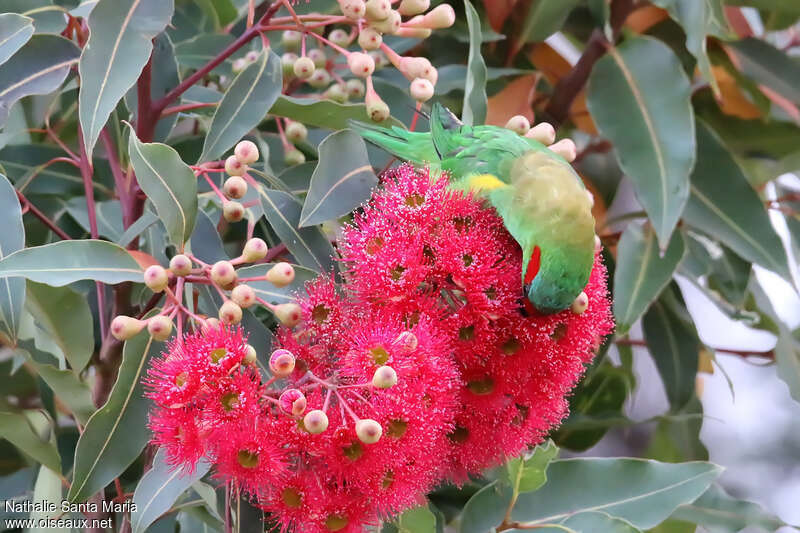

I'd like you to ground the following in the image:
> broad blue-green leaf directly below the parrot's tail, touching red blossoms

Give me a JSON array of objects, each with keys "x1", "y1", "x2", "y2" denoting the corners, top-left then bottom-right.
[{"x1": 300, "y1": 130, "x2": 378, "y2": 228}]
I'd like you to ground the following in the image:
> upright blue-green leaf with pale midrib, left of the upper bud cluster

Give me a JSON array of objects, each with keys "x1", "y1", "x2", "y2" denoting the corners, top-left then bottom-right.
[{"x1": 200, "y1": 50, "x2": 283, "y2": 162}]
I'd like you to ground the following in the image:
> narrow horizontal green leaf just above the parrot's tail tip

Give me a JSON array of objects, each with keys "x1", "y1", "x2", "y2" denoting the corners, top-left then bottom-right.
[{"x1": 269, "y1": 96, "x2": 404, "y2": 130}]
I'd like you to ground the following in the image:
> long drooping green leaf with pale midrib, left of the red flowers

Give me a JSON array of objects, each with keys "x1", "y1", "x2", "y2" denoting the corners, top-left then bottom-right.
[{"x1": 67, "y1": 331, "x2": 162, "y2": 502}]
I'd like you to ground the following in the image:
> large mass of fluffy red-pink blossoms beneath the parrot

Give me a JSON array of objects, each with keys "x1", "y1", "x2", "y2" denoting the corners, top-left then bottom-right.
[{"x1": 147, "y1": 166, "x2": 612, "y2": 533}]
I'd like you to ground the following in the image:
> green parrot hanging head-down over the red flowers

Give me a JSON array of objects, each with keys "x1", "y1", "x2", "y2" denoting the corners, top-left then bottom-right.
[{"x1": 351, "y1": 104, "x2": 595, "y2": 314}]
